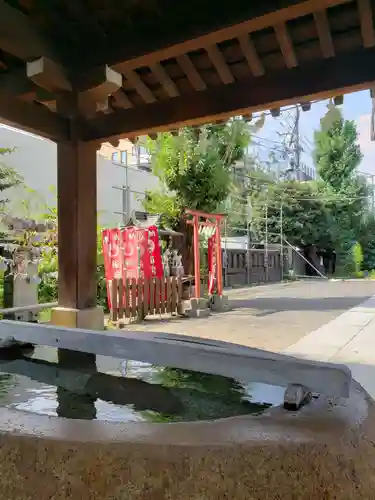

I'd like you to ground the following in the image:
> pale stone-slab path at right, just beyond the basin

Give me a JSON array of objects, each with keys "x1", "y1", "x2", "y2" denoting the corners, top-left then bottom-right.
[{"x1": 283, "y1": 295, "x2": 375, "y2": 399}]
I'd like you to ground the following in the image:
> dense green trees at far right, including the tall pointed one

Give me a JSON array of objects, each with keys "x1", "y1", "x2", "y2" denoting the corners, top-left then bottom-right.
[{"x1": 236, "y1": 109, "x2": 375, "y2": 272}]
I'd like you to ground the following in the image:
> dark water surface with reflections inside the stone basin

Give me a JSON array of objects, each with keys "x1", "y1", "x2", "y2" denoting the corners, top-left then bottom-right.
[{"x1": 0, "y1": 347, "x2": 284, "y2": 422}]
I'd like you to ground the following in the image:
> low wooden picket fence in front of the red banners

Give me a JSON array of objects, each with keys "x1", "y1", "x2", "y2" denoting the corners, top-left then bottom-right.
[{"x1": 110, "y1": 276, "x2": 182, "y2": 321}]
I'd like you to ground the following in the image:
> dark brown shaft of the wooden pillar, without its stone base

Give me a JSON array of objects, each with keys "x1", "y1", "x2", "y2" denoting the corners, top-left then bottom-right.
[{"x1": 57, "y1": 142, "x2": 97, "y2": 309}]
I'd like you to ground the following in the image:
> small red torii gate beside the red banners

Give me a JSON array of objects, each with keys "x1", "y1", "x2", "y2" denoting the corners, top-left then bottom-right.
[{"x1": 185, "y1": 209, "x2": 225, "y2": 298}]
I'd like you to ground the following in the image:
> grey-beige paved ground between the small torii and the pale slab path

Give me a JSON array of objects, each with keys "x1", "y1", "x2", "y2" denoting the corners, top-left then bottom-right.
[{"x1": 132, "y1": 281, "x2": 375, "y2": 351}]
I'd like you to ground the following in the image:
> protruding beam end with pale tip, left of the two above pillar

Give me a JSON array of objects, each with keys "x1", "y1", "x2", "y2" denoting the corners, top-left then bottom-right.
[{"x1": 26, "y1": 57, "x2": 72, "y2": 92}]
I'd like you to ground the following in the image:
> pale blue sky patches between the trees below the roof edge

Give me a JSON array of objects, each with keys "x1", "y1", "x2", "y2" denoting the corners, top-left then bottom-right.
[{"x1": 255, "y1": 90, "x2": 375, "y2": 175}]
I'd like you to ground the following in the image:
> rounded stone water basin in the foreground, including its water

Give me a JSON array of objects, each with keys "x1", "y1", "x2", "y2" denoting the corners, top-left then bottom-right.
[{"x1": 0, "y1": 348, "x2": 375, "y2": 500}]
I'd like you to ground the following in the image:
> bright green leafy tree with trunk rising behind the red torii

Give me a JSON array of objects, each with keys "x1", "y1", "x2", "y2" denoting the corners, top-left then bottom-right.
[{"x1": 144, "y1": 118, "x2": 258, "y2": 273}]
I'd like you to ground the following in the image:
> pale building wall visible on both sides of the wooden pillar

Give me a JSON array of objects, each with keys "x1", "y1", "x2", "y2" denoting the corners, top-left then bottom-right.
[{"x1": 0, "y1": 126, "x2": 159, "y2": 226}]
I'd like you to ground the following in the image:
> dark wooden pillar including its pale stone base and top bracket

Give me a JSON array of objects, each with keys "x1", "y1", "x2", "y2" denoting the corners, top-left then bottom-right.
[{"x1": 52, "y1": 93, "x2": 104, "y2": 329}]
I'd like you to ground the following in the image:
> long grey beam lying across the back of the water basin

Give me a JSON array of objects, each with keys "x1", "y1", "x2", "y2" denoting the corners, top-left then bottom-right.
[{"x1": 0, "y1": 320, "x2": 352, "y2": 397}]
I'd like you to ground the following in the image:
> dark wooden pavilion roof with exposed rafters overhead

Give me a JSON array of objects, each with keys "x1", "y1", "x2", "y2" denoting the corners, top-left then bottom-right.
[{"x1": 0, "y1": 0, "x2": 375, "y2": 142}]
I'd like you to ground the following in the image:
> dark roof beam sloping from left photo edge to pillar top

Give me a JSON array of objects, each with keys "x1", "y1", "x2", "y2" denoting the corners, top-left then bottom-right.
[{"x1": 0, "y1": 93, "x2": 69, "y2": 141}]
